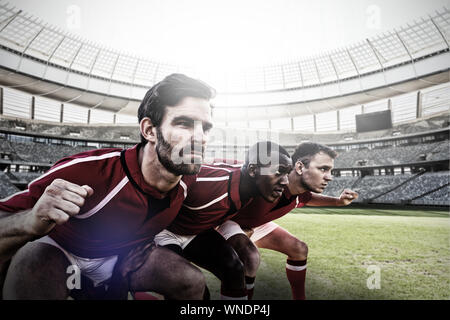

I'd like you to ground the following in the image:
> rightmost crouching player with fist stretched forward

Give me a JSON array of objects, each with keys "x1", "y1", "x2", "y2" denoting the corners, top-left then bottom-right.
[{"x1": 218, "y1": 142, "x2": 358, "y2": 300}]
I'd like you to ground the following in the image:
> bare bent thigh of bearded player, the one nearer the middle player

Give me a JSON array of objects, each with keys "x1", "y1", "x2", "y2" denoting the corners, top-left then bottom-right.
[{"x1": 130, "y1": 247, "x2": 205, "y2": 294}]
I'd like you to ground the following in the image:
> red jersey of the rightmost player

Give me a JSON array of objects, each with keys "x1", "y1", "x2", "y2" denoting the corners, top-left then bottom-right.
[{"x1": 232, "y1": 188, "x2": 311, "y2": 228}]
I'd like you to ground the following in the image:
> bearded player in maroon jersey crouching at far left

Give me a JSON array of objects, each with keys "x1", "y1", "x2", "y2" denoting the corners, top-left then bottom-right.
[{"x1": 0, "y1": 74, "x2": 214, "y2": 299}]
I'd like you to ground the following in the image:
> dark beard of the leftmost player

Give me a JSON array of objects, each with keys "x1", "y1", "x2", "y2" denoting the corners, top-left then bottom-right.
[{"x1": 156, "y1": 128, "x2": 204, "y2": 176}]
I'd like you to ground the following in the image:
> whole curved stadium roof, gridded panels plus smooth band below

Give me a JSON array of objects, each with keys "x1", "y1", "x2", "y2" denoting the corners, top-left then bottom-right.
[{"x1": 0, "y1": 4, "x2": 450, "y2": 123}]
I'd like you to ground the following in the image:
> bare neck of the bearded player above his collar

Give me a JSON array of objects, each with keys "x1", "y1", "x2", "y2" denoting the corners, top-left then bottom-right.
[{"x1": 139, "y1": 142, "x2": 181, "y2": 193}]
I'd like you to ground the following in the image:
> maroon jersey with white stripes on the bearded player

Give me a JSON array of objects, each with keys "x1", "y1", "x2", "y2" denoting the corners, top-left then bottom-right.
[{"x1": 0, "y1": 145, "x2": 195, "y2": 258}]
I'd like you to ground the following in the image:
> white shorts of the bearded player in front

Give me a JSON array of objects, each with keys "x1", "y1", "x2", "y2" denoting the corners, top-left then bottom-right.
[{"x1": 33, "y1": 236, "x2": 118, "y2": 287}]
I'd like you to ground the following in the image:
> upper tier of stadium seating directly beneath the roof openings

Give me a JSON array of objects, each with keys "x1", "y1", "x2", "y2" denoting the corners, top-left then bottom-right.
[{"x1": 0, "y1": 115, "x2": 450, "y2": 171}]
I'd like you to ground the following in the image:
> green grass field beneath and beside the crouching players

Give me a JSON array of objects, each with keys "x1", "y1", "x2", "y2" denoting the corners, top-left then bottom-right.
[{"x1": 201, "y1": 208, "x2": 450, "y2": 300}]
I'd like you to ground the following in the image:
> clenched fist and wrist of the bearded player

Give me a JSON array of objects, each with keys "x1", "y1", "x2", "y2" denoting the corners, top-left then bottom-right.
[{"x1": 26, "y1": 179, "x2": 94, "y2": 236}]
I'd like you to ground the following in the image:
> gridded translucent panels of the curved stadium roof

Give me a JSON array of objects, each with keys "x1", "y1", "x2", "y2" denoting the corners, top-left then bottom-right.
[{"x1": 0, "y1": 4, "x2": 450, "y2": 92}]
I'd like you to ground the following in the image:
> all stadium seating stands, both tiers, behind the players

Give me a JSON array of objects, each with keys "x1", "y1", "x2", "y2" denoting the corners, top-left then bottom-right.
[{"x1": 0, "y1": 115, "x2": 450, "y2": 206}]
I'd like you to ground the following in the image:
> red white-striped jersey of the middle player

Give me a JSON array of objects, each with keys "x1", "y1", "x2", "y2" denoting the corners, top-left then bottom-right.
[{"x1": 167, "y1": 163, "x2": 246, "y2": 235}]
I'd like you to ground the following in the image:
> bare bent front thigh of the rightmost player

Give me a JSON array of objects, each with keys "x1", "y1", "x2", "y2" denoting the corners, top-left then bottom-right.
[{"x1": 255, "y1": 226, "x2": 306, "y2": 256}]
